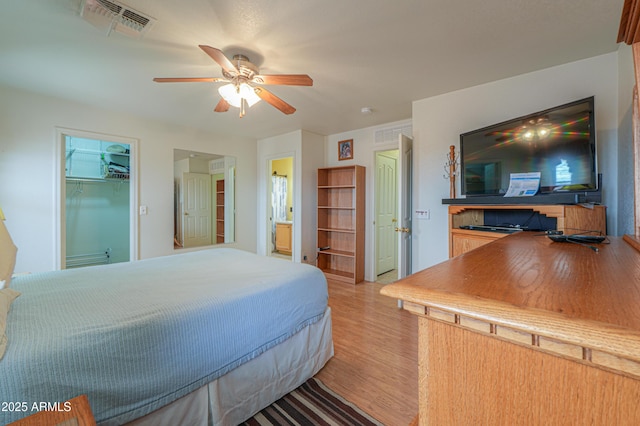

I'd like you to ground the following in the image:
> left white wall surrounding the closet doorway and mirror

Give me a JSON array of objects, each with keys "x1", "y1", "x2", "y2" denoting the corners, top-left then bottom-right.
[{"x1": 0, "y1": 86, "x2": 256, "y2": 272}]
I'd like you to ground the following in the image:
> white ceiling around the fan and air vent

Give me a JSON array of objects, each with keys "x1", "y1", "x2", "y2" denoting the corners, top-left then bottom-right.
[{"x1": 0, "y1": 0, "x2": 624, "y2": 138}]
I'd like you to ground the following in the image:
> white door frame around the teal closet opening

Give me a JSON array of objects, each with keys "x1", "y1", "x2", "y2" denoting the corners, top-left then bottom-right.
[{"x1": 53, "y1": 127, "x2": 139, "y2": 270}]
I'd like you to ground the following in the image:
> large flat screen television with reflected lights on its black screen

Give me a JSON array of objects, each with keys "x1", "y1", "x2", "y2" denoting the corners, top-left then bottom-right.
[{"x1": 460, "y1": 96, "x2": 598, "y2": 197}]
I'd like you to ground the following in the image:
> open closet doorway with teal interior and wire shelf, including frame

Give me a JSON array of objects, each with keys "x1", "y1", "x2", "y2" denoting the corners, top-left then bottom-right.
[{"x1": 56, "y1": 129, "x2": 137, "y2": 269}]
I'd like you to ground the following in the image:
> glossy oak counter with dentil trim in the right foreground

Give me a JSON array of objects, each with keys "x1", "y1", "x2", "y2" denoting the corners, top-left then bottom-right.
[{"x1": 382, "y1": 232, "x2": 640, "y2": 425}]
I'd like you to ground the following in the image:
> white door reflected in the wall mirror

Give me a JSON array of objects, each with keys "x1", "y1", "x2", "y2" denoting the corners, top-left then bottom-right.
[{"x1": 182, "y1": 173, "x2": 212, "y2": 247}]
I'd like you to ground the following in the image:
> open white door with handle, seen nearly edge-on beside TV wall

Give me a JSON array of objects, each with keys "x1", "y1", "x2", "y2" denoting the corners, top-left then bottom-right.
[{"x1": 397, "y1": 134, "x2": 413, "y2": 279}]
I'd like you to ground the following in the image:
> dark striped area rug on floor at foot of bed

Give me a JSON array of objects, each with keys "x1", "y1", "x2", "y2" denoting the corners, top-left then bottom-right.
[{"x1": 242, "y1": 378, "x2": 383, "y2": 426}]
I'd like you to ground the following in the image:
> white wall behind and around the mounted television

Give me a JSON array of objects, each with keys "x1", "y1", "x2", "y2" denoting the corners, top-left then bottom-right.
[{"x1": 413, "y1": 53, "x2": 619, "y2": 272}]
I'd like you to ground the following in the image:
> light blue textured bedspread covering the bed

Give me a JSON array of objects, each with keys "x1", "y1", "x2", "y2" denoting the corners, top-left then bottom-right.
[{"x1": 0, "y1": 248, "x2": 328, "y2": 424}]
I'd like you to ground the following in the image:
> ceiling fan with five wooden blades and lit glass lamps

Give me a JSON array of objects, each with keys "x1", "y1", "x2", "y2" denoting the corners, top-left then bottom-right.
[{"x1": 153, "y1": 45, "x2": 313, "y2": 117}]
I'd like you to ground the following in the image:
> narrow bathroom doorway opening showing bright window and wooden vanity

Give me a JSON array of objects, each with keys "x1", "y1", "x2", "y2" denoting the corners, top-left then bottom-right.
[{"x1": 267, "y1": 157, "x2": 293, "y2": 260}]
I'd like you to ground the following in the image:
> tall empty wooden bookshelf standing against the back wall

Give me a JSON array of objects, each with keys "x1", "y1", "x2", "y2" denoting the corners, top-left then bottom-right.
[{"x1": 317, "y1": 166, "x2": 365, "y2": 284}]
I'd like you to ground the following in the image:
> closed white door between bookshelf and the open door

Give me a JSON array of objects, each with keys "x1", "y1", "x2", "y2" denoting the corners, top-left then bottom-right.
[{"x1": 376, "y1": 152, "x2": 398, "y2": 275}]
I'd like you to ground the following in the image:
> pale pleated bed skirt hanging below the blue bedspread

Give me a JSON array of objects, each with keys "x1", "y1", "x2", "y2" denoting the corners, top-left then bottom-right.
[{"x1": 125, "y1": 307, "x2": 333, "y2": 426}]
